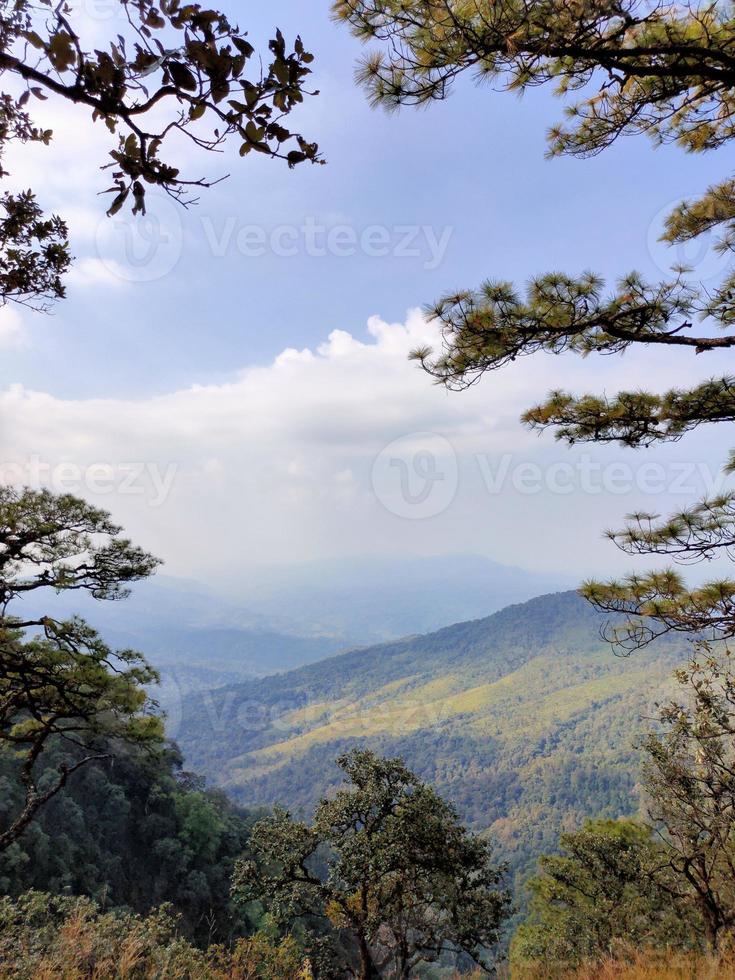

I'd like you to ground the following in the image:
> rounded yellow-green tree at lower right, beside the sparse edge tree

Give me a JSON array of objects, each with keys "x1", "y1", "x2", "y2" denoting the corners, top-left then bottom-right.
[{"x1": 511, "y1": 820, "x2": 697, "y2": 970}]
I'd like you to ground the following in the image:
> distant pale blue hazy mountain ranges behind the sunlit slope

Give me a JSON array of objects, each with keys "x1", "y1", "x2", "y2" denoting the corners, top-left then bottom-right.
[{"x1": 21, "y1": 556, "x2": 558, "y2": 710}]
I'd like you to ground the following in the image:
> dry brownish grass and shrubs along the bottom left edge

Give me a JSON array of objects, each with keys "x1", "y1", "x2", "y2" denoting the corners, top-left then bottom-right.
[{"x1": 0, "y1": 892, "x2": 312, "y2": 980}]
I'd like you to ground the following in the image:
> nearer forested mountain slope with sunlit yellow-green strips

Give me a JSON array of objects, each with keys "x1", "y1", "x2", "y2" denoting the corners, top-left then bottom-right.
[{"x1": 178, "y1": 593, "x2": 684, "y2": 888}]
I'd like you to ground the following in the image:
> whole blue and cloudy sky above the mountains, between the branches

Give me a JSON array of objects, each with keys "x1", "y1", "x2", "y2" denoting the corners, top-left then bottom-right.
[{"x1": 0, "y1": 0, "x2": 730, "y2": 582}]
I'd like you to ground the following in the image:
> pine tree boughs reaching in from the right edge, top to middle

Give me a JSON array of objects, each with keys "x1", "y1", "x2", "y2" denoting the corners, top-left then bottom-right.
[{"x1": 334, "y1": 0, "x2": 735, "y2": 652}]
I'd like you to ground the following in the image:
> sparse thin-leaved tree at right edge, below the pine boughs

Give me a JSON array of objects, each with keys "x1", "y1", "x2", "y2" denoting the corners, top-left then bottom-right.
[{"x1": 643, "y1": 644, "x2": 735, "y2": 949}]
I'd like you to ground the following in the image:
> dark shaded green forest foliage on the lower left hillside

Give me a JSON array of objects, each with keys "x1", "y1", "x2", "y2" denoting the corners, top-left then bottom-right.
[{"x1": 0, "y1": 739, "x2": 254, "y2": 944}]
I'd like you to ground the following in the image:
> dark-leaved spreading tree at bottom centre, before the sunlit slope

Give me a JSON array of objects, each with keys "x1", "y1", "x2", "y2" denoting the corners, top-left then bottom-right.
[{"x1": 234, "y1": 750, "x2": 509, "y2": 980}]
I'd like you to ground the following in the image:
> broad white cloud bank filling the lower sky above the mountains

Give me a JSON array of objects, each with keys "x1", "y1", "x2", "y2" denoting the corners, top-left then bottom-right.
[{"x1": 0, "y1": 311, "x2": 725, "y2": 576}]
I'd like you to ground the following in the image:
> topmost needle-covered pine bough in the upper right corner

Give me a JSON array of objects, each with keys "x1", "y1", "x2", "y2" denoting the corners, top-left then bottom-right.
[{"x1": 334, "y1": 0, "x2": 735, "y2": 149}]
